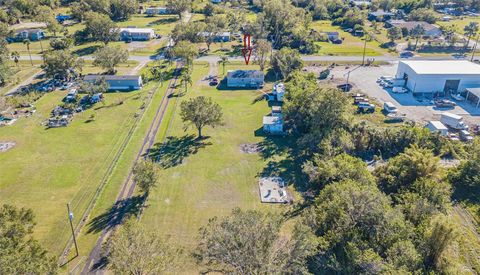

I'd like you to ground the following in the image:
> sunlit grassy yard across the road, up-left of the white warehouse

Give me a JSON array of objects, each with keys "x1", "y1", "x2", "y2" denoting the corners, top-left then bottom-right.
[{"x1": 311, "y1": 20, "x2": 387, "y2": 56}]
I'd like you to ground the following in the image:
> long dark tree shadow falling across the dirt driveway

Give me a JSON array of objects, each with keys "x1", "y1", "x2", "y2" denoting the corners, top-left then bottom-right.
[{"x1": 87, "y1": 196, "x2": 145, "y2": 234}]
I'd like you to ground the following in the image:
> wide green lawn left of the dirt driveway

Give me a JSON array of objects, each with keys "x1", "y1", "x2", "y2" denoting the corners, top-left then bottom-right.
[{"x1": 0, "y1": 84, "x2": 154, "y2": 255}]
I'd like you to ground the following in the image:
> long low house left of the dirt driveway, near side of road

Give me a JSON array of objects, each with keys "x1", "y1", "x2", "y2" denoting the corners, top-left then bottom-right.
[{"x1": 83, "y1": 75, "x2": 143, "y2": 91}]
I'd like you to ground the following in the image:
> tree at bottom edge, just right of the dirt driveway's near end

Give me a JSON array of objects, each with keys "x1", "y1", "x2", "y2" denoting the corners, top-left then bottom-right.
[{"x1": 106, "y1": 221, "x2": 186, "y2": 274}]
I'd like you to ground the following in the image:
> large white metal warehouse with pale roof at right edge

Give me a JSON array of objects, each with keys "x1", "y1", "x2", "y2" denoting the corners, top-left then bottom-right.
[{"x1": 396, "y1": 60, "x2": 480, "y2": 95}]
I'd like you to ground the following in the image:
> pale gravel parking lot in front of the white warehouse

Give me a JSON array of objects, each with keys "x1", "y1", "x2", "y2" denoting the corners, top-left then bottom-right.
[{"x1": 332, "y1": 63, "x2": 480, "y2": 124}]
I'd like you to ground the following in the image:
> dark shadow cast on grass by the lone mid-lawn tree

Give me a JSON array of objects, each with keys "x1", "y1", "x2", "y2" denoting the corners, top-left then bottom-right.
[{"x1": 147, "y1": 135, "x2": 212, "y2": 169}]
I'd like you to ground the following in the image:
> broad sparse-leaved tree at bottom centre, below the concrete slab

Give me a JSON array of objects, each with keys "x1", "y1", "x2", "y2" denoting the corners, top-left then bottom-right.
[{"x1": 195, "y1": 208, "x2": 315, "y2": 274}]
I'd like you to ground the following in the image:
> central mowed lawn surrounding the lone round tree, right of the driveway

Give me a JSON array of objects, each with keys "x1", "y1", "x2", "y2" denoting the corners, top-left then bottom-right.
[{"x1": 142, "y1": 64, "x2": 286, "y2": 269}]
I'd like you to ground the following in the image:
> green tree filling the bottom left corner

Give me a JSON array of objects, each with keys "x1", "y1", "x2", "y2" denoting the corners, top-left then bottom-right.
[{"x1": 0, "y1": 205, "x2": 57, "y2": 274}]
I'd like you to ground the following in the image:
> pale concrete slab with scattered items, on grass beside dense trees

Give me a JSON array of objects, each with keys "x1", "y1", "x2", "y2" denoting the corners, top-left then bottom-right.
[{"x1": 258, "y1": 177, "x2": 293, "y2": 203}]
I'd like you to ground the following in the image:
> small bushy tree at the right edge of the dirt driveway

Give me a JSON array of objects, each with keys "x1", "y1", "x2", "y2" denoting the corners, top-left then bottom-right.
[{"x1": 133, "y1": 160, "x2": 159, "y2": 197}]
